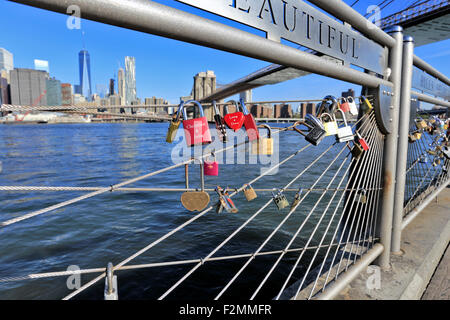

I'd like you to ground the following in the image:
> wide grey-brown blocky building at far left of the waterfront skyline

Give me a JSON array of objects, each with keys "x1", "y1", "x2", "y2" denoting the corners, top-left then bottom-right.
[{"x1": 10, "y1": 68, "x2": 49, "y2": 106}]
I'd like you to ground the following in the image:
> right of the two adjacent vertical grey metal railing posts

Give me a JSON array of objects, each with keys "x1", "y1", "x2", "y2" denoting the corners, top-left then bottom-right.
[{"x1": 391, "y1": 36, "x2": 414, "y2": 254}]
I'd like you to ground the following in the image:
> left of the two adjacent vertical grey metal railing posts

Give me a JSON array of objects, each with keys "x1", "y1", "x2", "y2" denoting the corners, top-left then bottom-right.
[{"x1": 376, "y1": 27, "x2": 403, "y2": 270}]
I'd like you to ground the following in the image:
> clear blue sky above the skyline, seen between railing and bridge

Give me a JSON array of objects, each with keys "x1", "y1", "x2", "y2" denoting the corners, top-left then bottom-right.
[{"x1": 0, "y1": 0, "x2": 450, "y2": 103}]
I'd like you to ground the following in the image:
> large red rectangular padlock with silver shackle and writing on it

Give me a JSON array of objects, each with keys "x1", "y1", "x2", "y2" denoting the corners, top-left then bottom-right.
[{"x1": 180, "y1": 100, "x2": 212, "y2": 147}]
